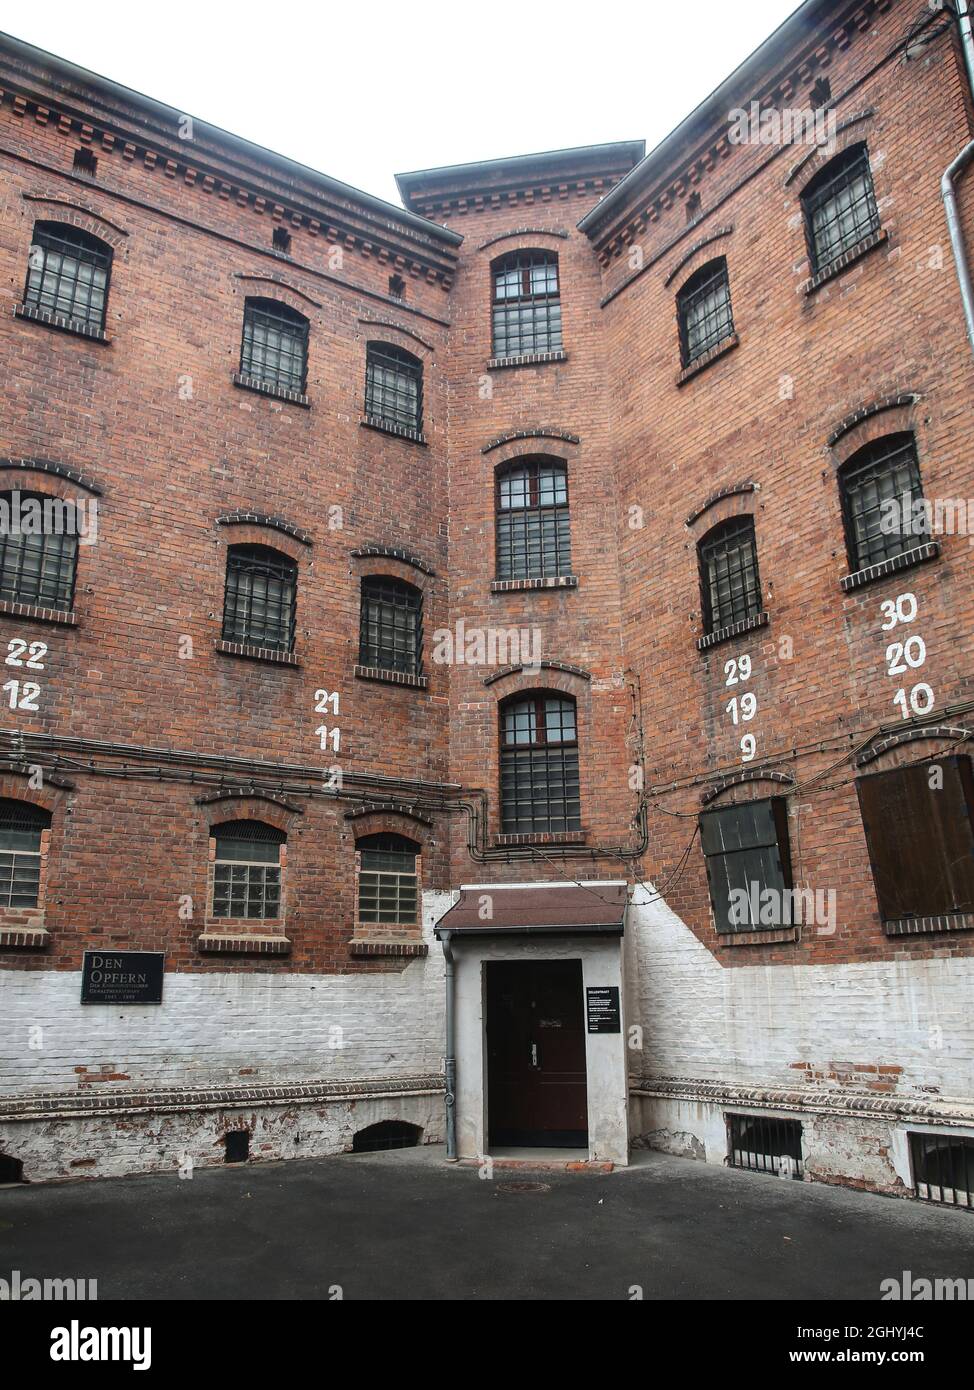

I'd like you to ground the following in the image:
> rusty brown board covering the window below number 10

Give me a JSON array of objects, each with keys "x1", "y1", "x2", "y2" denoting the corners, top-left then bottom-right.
[{"x1": 856, "y1": 756, "x2": 974, "y2": 922}]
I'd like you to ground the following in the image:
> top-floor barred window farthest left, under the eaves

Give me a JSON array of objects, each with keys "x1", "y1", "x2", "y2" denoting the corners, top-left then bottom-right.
[{"x1": 24, "y1": 222, "x2": 111, "y2": 329}]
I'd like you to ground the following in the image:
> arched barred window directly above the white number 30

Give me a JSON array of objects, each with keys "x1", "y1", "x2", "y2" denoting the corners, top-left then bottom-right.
[{"x1": 839, "y1": 431, "x2": 930, "y2": 573}]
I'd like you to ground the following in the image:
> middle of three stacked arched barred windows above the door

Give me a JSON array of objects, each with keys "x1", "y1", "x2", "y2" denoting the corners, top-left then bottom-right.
[{"x1": 497, "y1": 459, "x2": 571, "y2": 580}]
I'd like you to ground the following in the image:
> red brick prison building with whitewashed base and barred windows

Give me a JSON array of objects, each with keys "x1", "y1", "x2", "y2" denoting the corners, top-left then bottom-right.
[{"x1": 0, "y1": 0, "x2": 974, "y2": 1202}]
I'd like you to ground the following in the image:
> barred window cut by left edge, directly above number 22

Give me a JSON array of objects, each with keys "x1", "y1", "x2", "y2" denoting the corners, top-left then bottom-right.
[{"x1": 0, "y1": 492, "x2": 78, "y2": 613}]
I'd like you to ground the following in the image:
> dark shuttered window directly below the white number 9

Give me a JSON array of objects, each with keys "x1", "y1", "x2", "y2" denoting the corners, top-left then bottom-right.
[{"x1": 700, "y1": 796, "x2": 792, "y2": 935}]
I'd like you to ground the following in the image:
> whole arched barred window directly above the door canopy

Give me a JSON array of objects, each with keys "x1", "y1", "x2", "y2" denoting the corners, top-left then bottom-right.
[{"x1": 500, "y1": 691, "x2": 582, "y2": 834}]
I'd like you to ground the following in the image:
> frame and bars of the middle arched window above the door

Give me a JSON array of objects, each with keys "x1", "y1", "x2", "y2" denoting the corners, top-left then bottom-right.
[{"x1": 493, "y1": 455, "x2": 572, "y2": 580}]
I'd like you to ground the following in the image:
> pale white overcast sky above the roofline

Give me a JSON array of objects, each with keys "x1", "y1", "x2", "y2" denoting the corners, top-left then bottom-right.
[{"x1": 0, "y1": 0, "x2": 798, "y2": 203}]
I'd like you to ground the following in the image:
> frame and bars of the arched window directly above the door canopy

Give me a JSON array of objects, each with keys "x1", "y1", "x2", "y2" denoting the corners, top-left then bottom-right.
[{"x1": 497, "y1": 689, "x2": 582, "y2": 835}]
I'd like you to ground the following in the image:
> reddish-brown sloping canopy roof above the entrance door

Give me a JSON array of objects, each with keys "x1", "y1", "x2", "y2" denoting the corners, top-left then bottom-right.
[{"x1": 435, "y1": 881, "x2": 628, "y2": 937}]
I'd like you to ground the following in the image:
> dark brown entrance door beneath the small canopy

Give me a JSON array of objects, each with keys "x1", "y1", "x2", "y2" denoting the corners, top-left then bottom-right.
[{"x1": 486, "y1": 960, "x2": 588, "y2": 1148}]
